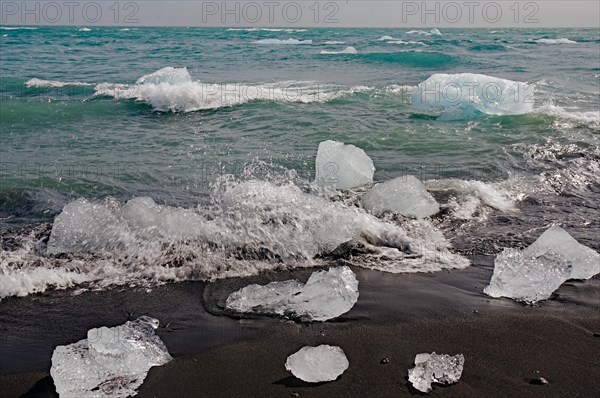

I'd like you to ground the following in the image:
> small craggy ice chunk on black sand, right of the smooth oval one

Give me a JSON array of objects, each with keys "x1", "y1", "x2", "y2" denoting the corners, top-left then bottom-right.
[{"x1": 408, "y1": 352, "x2": 465, "y2": 393}]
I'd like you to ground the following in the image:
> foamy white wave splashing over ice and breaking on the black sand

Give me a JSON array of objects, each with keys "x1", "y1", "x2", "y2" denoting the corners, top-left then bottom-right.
[{"x1": 0, "y1": 173, "x2": 469, "y2": 297}]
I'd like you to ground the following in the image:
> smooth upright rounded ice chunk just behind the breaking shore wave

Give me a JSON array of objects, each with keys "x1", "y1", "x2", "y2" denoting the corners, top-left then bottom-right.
[{"x1": 316, "y1": 140, "x2": 375, "y2": 189}]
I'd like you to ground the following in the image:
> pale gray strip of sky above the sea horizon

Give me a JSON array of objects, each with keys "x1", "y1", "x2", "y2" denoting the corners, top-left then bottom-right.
[{"x1": 0, "y1": 0, "x2": 600, "y2": 29}]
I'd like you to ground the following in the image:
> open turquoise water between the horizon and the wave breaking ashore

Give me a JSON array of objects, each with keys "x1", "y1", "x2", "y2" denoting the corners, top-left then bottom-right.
[{"x1": 0, "y1": 27, "x2": 600, "y2": 223}]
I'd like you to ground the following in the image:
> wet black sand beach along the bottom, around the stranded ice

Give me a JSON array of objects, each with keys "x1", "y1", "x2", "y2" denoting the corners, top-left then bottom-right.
[{"x1": 0, "y1": 258, "x2": 600, "y2": 398}]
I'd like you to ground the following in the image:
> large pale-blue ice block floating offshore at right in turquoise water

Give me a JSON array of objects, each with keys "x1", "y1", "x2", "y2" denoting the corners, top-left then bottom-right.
[{"x1": 412, "y1": 73, "x2": 534, "y2": 120}]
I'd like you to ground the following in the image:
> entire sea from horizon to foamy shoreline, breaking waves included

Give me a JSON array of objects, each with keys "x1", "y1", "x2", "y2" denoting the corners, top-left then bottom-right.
[{"x1": 0, "y1": 26, "x2": 600, "y2": 298}]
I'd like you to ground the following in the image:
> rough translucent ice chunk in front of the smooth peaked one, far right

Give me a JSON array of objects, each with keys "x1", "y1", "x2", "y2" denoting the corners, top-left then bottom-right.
[{"x1": 483, "y1": 249, "x2": 571, "y2": 304}]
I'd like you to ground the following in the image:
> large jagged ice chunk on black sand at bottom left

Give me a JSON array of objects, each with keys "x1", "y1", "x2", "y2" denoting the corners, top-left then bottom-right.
[{"x1": 50, "y1": 316, "x2": 172, "y2": 398}]
